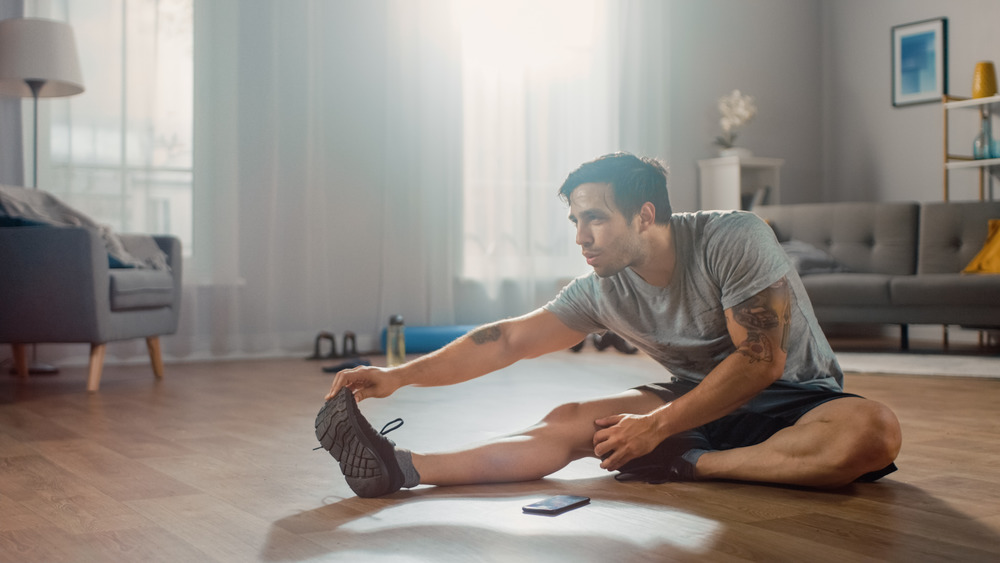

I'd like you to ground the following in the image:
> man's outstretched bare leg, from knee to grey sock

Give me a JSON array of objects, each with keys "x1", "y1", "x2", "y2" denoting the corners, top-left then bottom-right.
[{"x1": 413, "y1": 389, "x2": 663, "y2": 485}]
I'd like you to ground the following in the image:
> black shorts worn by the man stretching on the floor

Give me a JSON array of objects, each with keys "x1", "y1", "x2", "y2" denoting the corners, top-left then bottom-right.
[{"x1": 636, "y1": 379, "x2": 861, "y2": 450}]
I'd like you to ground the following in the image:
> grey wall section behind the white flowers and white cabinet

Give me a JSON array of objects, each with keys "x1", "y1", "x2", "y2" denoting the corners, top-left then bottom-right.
[{"x1": 668, "y1": 0, "x2": 822, "y2": 211}]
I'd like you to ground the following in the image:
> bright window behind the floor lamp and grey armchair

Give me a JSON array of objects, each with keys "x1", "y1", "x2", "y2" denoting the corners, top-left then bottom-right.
[{"x1": 25, "y1": 0, "x2": 193, "y2": 253}]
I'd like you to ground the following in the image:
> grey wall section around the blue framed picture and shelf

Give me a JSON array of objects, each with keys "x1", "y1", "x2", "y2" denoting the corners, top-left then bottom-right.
[{"x1": 821, "y1": 0, "x2": 1000, "y2": 201}]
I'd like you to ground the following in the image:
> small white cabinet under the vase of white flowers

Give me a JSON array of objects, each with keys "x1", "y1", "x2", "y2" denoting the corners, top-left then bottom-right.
[{"x1": 698, "y1": 156, "x2": 785, "y2": 209}]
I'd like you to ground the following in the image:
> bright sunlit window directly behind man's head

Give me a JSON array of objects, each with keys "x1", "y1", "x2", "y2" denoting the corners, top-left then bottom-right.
[{"x1": 457, "y1": 0, "x2": 618, "y2": 281}]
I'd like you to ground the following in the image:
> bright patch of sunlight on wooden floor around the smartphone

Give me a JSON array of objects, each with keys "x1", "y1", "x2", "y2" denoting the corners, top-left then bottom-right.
[{"x1": 340, "y1": 495, "x2": 722, "y2": 553}]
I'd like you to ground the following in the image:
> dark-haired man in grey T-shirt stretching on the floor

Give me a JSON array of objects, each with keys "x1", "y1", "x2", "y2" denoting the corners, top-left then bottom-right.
[{"x1": 316, "y1": 153, "x2": 901, "y2": 497}]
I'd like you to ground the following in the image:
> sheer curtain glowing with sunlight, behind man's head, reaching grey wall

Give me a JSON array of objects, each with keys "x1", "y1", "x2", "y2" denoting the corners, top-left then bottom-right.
[{"x1": 457, "y1": 0, "x2": 668, "y2": 320}]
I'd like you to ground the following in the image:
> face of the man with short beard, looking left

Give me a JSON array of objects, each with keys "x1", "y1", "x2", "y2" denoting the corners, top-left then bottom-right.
[{"x1": 569, "y1": 184, "x2": 643, "y2": 278}]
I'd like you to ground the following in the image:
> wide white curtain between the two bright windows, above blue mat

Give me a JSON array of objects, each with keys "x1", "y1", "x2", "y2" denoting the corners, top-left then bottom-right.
[{"x1": 167, "y1": 0, "x2": 461, "y2": 358}]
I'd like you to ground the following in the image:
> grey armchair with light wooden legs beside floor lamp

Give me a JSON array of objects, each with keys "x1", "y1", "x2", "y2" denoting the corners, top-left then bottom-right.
[{"x1": 0, "y1": 226, "x2": 181, "y2": 391}]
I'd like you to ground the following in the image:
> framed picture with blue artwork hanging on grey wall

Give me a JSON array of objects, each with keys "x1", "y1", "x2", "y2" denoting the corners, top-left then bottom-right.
[{"x1": 892, "y1": 18, "x2": 948, "y2": 107}]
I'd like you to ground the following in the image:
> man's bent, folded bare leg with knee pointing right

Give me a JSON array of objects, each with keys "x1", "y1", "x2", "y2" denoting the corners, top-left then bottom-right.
[{"x1": 695, "y1": 397, "x2": 902, "y2": 487}]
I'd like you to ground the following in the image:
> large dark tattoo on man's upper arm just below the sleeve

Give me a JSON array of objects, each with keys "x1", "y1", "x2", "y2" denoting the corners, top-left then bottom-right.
[{"x1": 733, "y1": 278, "x2": 791, "y2": 363}]
